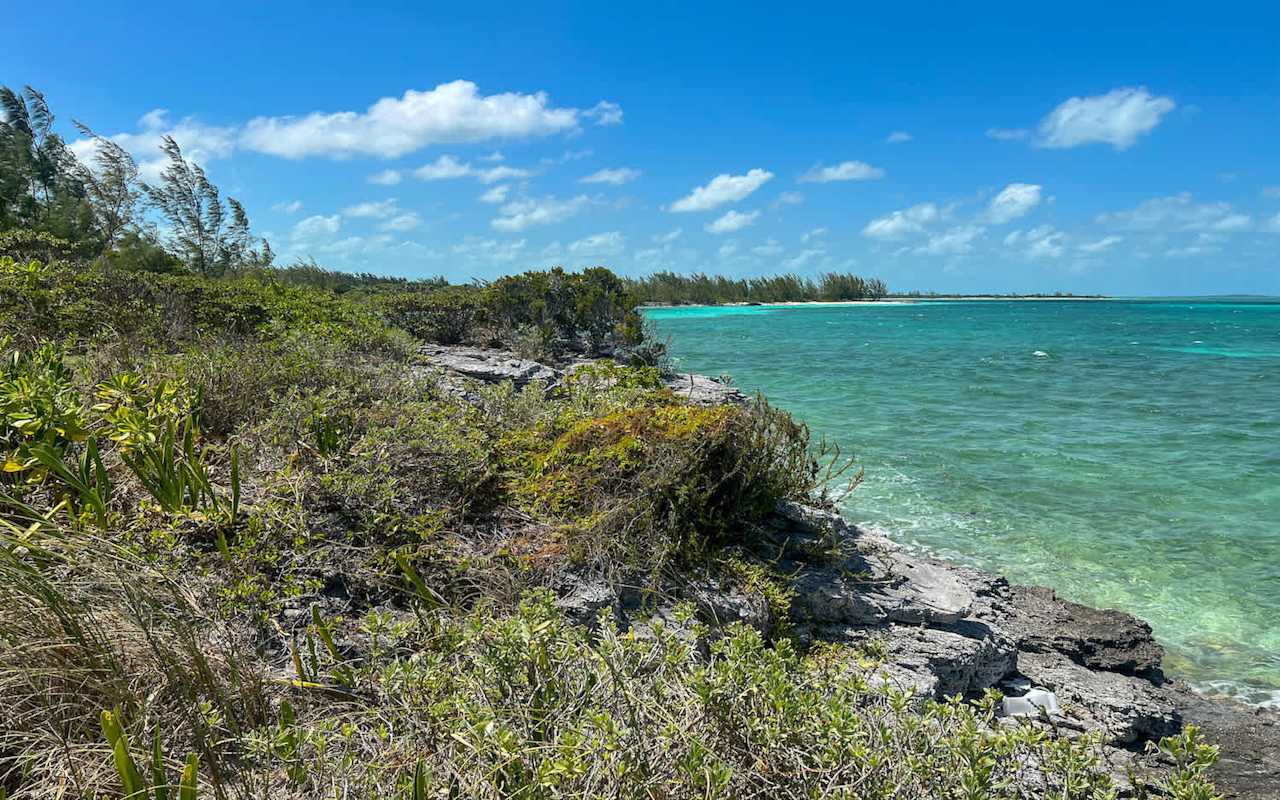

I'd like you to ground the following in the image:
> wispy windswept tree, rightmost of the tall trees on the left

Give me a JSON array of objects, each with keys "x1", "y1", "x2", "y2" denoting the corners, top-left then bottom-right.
[{"x1": 143, "y1": 136, "x2": 261, "y2": 276}]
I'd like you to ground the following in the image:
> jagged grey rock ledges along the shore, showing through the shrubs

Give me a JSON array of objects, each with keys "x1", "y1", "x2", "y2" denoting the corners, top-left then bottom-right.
[{"x1": 422, "y1": 346, "x2": 1280, "y2": 799}]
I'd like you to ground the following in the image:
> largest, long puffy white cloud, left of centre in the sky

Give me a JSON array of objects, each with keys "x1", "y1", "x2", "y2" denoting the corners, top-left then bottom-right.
[{"x1": 241, "y1": 81, "x2": 596, "y2": 159}]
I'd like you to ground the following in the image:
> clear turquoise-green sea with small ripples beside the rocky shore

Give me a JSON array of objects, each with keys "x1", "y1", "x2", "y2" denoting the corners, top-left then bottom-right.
[{"x1": 646, "y1": 298, "x2": 1280, "y2": 704}]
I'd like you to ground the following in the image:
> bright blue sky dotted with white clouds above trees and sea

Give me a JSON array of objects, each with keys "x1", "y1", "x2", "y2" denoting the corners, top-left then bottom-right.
[{"x1": 0, "y1": 1, "x2": 1280, "y2": 294}]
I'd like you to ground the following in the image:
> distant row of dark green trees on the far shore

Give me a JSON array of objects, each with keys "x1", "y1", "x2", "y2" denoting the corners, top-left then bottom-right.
[{"x1": 631, "y1": 273, "x2": 888, "y2": 306}]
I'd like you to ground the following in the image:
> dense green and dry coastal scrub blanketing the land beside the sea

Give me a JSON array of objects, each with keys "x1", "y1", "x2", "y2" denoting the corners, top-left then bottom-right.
[{"x1": 0, "y1": 84, "x2": 1212, "y2": 800}]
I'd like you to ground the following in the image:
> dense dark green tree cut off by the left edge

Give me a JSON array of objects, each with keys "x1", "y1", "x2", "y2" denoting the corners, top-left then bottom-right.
[{"x1": 0, "y1": 86, "x2": 93, "y2": 242}]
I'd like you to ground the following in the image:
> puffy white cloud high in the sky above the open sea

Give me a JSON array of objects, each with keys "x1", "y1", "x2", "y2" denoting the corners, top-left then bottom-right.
[{"x1": 1036, "y1": 87, "x2": 1178, "y2": 150}]
